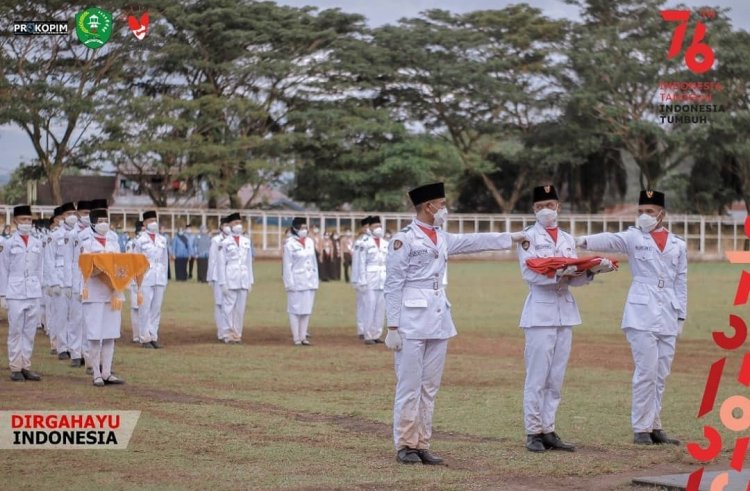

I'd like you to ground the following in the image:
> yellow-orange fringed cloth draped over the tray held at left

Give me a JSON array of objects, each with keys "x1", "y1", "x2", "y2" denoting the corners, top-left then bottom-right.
[{"x1": 78, "y1": 252, "x2": 149, "y2": 310}]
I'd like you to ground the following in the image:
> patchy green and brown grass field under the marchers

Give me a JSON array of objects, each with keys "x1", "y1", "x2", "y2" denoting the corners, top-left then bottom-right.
[{"x1": 0, "y1": 261, "x2": 742, "y2": 491}]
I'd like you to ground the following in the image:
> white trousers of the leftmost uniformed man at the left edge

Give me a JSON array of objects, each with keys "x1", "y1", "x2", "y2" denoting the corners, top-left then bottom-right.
[{"x1": 7, "y1": 298, "x2": 40, "y2": 372}]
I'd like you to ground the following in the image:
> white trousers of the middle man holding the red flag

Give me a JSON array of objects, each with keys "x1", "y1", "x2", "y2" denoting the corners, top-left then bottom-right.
[{"x1": 523, "y1": 327, "x2": 573, "y2": 435}]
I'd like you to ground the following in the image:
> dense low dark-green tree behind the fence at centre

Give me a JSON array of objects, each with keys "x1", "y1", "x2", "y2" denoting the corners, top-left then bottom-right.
[{"x1": 292, "y1": 99, "x2": 459, "y2": 211}]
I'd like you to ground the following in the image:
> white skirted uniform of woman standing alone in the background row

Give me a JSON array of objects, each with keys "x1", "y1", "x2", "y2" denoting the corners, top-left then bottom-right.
[{"x1": 281, "y1": 235, "x2": 319, "y2": 344}]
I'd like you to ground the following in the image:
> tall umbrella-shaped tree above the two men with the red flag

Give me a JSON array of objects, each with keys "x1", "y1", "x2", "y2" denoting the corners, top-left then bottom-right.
[{"x1": 374, "y1": 4, "x2": 566, "y2": 211}]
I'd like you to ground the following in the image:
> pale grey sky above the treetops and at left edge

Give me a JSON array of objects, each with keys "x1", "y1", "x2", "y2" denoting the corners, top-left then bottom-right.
[{"x1": 0, "y1": 0, "x2": 750, "y2": 175}]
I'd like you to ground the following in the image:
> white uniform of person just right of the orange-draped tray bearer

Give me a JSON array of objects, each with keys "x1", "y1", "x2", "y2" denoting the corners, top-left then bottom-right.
[{"x1": 135, "y1": 231, "x2": 169, "y2": 343}]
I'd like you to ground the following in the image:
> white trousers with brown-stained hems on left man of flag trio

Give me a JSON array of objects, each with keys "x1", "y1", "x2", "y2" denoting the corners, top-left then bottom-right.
[{"x1": 393, "y1": 339, "x2": 448, "y2": 450}]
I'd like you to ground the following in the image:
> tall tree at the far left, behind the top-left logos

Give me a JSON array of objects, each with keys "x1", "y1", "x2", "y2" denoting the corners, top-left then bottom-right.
[{"x1": 0, "y1": 0, "x2": 130, "y2": 202}]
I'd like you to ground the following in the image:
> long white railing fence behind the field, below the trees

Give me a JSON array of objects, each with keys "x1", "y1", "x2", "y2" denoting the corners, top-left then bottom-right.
[{"x1": 0, "y1": 205, "x2": 745, "y2": 259}]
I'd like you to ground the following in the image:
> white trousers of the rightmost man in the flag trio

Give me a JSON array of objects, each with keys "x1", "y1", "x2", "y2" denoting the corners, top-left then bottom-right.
[{"x1": 624, "y1": 328, "x2": 677, "y2": 433}]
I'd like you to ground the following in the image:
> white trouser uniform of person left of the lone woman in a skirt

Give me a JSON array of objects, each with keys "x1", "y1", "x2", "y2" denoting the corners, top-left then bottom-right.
[{"x1": 214, "y1": 235, "x2": 254, "y2": 341}]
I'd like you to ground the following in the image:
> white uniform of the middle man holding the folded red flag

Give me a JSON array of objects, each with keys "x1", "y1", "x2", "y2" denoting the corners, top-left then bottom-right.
[{"x1": 518, "y1": 223, "x2": 592, "y2": 435}]
